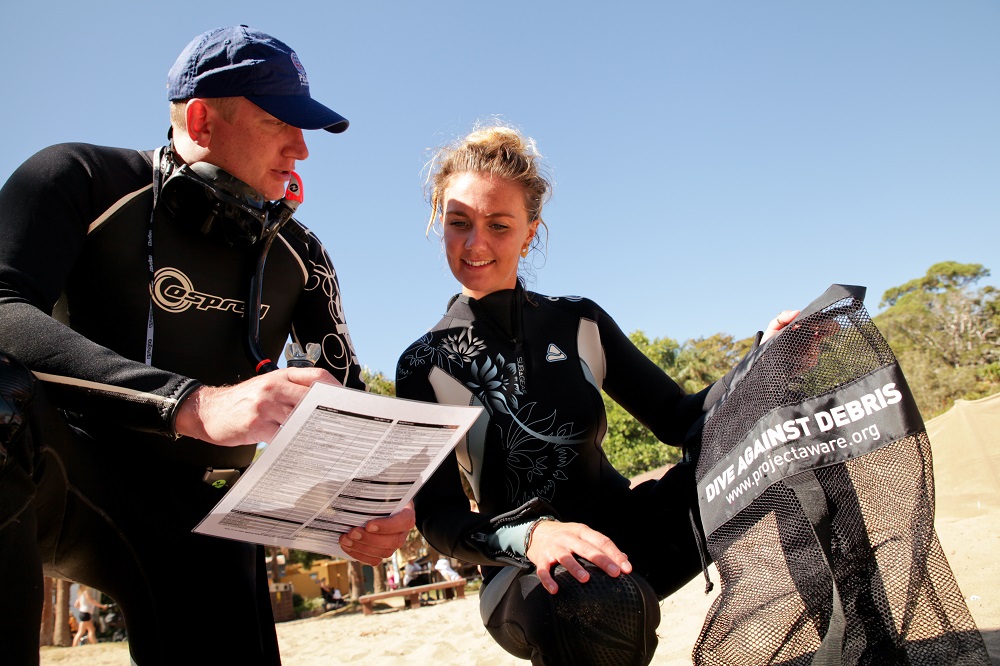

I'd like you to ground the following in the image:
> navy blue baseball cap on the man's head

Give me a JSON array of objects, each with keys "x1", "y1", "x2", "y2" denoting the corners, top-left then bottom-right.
[{"x1": 167, "y1": 25, "x2": 348, "y2": 132}]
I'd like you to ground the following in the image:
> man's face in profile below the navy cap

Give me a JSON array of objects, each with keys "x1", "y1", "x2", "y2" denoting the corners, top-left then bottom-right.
[{"x1": 205, "y1": 97, "x2": 309, "y2": 200}]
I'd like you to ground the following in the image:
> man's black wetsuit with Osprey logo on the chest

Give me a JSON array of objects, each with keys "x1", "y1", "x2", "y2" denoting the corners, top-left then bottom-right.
[{"x1": 0, "y1": 144, "x2": 364, "y2": 665}]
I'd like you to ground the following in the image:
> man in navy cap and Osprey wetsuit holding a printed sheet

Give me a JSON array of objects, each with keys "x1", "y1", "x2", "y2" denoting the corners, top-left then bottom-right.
[{"x1": 0, "y1": 26, "x2": 414, "y2": 666}]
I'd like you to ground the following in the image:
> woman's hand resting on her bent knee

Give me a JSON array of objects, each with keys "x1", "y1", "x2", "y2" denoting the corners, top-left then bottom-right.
[{"x1": 526, "y1": 520, "x2": 632, "y2": 594}]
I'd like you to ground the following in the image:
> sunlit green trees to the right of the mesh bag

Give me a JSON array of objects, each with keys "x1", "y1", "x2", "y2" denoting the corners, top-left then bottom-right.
[{"x1": 875, "y1": 261, "x2": 1000, "y2": 419}]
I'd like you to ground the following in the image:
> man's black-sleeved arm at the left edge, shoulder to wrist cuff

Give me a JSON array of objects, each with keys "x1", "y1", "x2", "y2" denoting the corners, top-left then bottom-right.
[{"x1": 0, "y1": 144, "x2": 203, "y2": 434}]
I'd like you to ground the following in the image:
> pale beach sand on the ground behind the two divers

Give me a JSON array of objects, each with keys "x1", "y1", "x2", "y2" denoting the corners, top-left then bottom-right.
[{"x1": 41, "y1": 511, "x2": 1000, "y2": 666}]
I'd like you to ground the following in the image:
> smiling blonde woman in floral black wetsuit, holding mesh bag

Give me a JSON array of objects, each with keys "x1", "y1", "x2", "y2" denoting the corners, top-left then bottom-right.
[{"x1": 396, "y1": 122, "x2": 796, "y2": 664}]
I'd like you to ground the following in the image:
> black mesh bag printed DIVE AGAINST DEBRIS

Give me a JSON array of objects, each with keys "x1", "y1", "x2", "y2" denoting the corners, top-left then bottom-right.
[{"x1": 693, "y1": 285, "x2": 989, "y2": 666}]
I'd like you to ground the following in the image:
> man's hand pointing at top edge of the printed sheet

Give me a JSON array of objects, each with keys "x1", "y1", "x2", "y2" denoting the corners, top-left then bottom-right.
[{"x1": 175, "y1": 368, "x2": 340, "y2": 446}]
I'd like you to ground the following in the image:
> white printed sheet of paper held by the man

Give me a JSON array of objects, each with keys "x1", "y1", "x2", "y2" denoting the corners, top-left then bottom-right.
[{"x1": 194, "y1": 383, "x2": 482, "y2": 557}]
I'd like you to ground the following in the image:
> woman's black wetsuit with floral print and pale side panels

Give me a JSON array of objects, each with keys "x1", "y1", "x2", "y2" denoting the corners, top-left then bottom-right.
[{"x1": 396, "y1": 285, "x2": 721, "y2": 663}]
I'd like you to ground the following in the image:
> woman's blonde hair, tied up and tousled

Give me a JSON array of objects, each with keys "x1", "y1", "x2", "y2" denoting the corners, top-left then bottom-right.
[{"x1": 427, "y1": 124, "x2": 552, "y2": 255}]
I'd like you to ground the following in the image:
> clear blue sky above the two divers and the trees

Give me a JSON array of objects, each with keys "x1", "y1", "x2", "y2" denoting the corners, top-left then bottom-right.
[{"x1": 0, "y1": 0, "x2": 1000, "y2": 376}]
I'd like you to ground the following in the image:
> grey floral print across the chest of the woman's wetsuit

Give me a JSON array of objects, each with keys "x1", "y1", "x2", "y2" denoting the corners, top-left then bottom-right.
[{"x1": 399, "y1": 328, "x2": 586, "y2": 506}]
